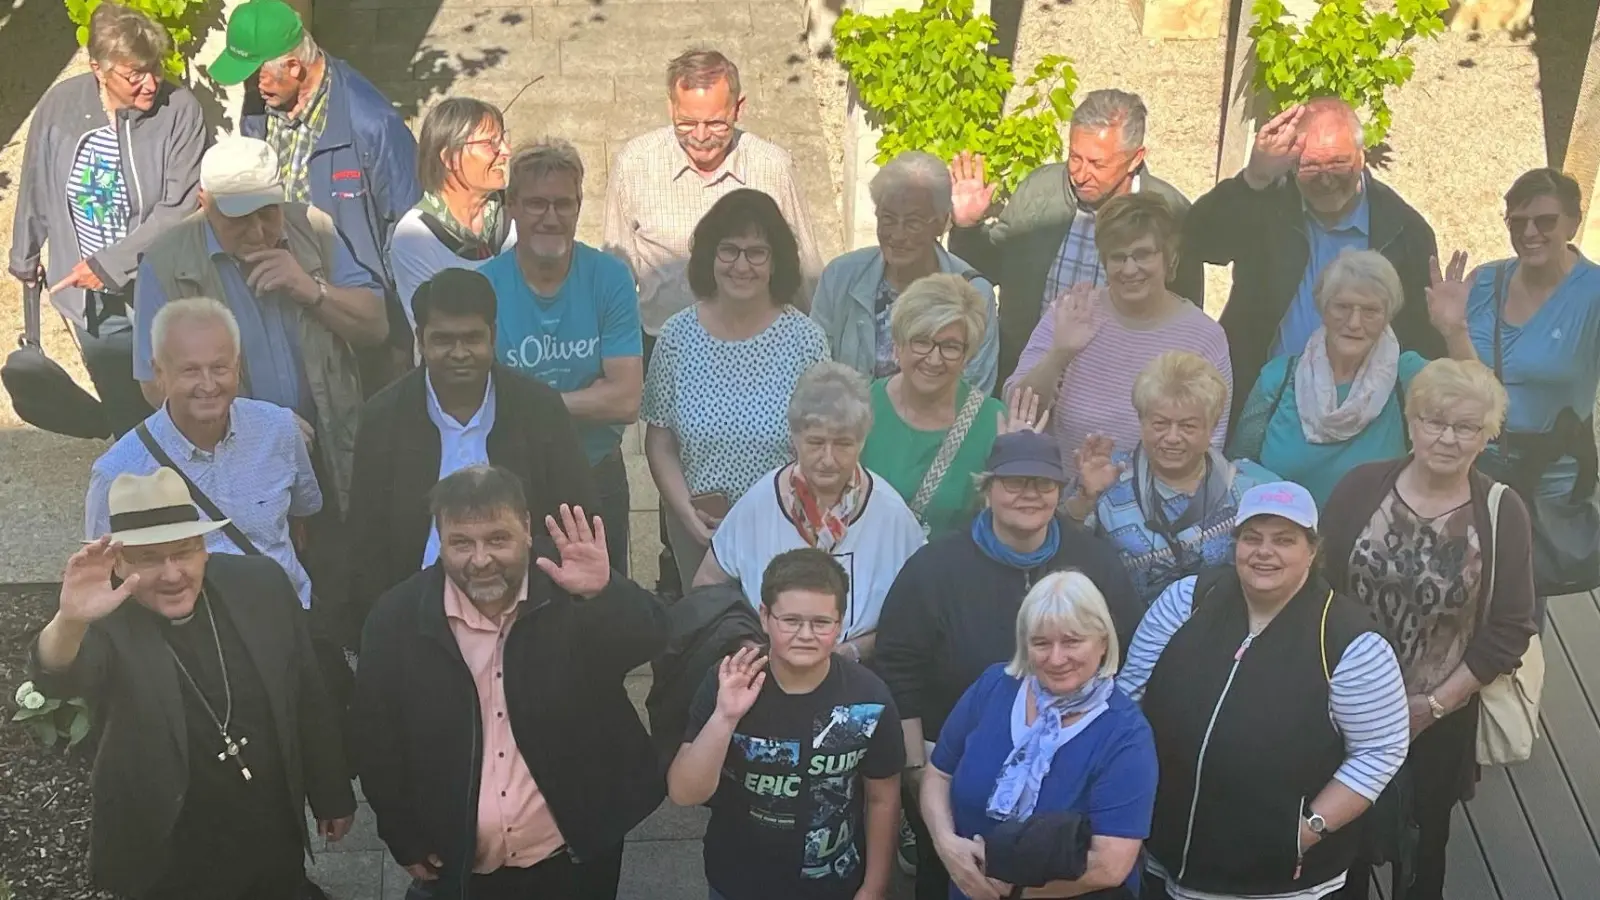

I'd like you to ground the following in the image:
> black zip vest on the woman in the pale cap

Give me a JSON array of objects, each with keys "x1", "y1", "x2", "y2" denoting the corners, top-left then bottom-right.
[{"x1": 1144, "y1": 567, "x2": 1371, "y2": 895}]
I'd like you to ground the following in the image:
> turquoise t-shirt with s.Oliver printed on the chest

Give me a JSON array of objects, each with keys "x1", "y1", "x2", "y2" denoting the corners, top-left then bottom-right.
[{"x1": 478, "y1": 243, "x2": 645, "y2": 466}]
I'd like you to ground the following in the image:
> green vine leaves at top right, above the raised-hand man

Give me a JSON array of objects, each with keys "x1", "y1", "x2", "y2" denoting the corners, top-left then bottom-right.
[{"x1": 1250, "y1": 0, "x2": 1450, "y2": 146}]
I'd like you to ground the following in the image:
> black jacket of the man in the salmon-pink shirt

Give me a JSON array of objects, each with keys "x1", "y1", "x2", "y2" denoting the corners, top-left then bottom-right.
[{"x1": 350, "y1": 560, "x2": 667, "y2": 897}]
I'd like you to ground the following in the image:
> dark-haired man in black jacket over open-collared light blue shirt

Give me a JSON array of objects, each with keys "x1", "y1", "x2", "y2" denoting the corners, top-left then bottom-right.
[{"x1": 346, "y1": 267, "x2": 601, "y2": 637}]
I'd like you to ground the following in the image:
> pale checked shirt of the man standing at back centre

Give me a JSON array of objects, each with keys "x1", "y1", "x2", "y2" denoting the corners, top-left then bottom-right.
[{"x1": 602, "y1": 125, "x2": 822, "y2": 335}]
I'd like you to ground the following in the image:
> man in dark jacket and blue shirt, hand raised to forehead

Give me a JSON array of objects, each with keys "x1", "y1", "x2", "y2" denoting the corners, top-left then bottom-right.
[{"x1": 1184, "y1": 98, "x2": 1446, "y2": 421}]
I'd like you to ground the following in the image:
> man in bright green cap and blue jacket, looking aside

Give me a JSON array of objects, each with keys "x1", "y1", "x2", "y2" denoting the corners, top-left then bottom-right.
[{"x1": 206, "y1": 0, "x2": 422, "y2": 373}]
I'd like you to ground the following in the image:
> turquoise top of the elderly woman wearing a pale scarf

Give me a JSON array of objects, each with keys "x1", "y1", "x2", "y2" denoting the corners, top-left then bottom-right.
[{"x1": 1256, "y1": 351, "x2": 1427, "y2": 508}]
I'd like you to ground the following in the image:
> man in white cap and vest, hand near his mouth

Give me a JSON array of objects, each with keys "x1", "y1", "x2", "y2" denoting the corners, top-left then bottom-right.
[{"x1": 133, "y1": 131, "x2": 389, "y2": 511}]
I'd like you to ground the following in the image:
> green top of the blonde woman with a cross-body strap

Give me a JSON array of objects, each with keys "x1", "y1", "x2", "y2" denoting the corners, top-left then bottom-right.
[{"x1": 861, "y1": 378, "x2": 1005, "y2": 538}]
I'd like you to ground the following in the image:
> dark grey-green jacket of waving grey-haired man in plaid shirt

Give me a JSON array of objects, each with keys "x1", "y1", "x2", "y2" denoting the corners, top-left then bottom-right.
[{"x1": 950, "y1": 162, "x2": 1205, "y2": 387}]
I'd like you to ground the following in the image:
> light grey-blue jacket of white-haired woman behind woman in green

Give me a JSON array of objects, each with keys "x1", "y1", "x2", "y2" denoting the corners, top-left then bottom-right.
[{"x1": 811, "y1": 247, "x2": 1000, "y2": 394}]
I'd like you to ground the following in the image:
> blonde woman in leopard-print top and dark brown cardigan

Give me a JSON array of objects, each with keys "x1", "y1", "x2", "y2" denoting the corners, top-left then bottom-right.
[{"x1": 1323, "y1": 359, "x2": 1534, "y2": 900}]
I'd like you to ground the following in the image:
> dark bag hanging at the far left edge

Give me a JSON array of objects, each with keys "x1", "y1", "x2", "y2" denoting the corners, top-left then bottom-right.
[{"x1": 0, "y1": 280, "x2": 110, "y2": 439}]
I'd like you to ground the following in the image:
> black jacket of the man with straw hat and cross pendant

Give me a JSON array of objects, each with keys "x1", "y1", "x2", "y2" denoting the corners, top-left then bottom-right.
[{"x1": 29, "y1": 554, "x2": 355, "y2": 897}]
